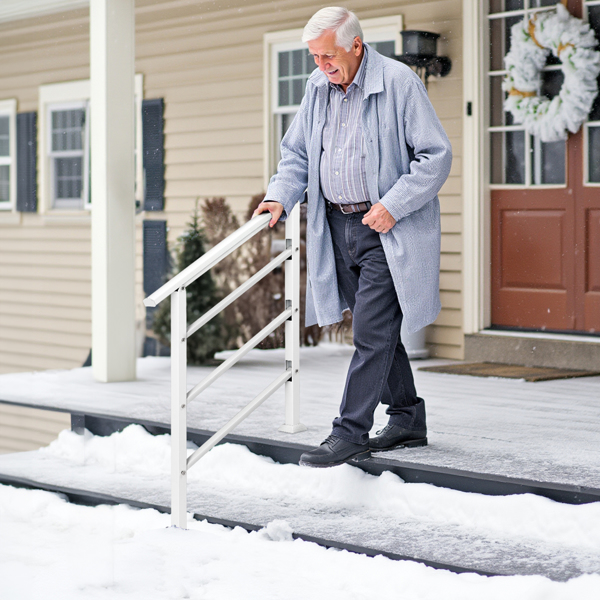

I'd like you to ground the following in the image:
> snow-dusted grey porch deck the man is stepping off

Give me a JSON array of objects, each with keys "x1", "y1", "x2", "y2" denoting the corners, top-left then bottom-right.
[{"x1": 0, "y1": 344, "x2": 600, "y2": 499}]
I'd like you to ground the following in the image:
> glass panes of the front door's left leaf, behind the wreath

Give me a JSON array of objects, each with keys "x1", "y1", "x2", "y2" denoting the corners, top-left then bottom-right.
[{"x1": 488, "y1": 0, "x2": 566, "y2": 186}]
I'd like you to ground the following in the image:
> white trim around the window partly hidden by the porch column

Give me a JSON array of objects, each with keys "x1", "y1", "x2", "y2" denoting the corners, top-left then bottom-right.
[{"x1": 37, "y1": 74, "x2": 144, "y2": 216}]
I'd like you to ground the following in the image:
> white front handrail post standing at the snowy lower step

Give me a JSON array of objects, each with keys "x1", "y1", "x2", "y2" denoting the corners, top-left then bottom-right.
[{"x1": 171, "y1": 287, "x2": 187, "y2": 529}]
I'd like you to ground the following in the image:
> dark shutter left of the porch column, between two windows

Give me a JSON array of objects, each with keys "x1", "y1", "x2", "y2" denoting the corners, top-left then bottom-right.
[{"x1": 17, "y1": 112, "x2": 37, "y2": 212}]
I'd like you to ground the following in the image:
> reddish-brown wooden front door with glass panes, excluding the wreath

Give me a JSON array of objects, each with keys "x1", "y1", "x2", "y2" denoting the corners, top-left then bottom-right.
[{"x1": 489, "y1": 0, "x2": 600, "y2": 334}]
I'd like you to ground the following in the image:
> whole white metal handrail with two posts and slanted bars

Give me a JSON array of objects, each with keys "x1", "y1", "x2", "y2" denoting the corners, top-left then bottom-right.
[{"x1": 144, "y1": 207, "x2": 306, "y2": 529}]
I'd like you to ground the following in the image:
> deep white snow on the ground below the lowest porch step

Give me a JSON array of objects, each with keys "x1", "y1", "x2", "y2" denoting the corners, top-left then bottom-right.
[{"x1": 0, "y1": 486, "x2": 600, "y2": 600}]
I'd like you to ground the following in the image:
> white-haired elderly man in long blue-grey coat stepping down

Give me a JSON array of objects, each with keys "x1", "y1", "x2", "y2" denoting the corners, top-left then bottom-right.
[{"x1": 255, "y1": 7, "x2": 452, "y2": 467}]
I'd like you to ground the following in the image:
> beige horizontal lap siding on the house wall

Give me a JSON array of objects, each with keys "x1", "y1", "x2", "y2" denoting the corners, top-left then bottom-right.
[{"x1": 0, "y1": 0, "x2": 463, "y2": 447}]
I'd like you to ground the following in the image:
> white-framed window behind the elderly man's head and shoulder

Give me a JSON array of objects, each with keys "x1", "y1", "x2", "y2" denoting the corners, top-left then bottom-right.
[{"x1": 264, "y1": 15, "x2": 402, "y2": 182}]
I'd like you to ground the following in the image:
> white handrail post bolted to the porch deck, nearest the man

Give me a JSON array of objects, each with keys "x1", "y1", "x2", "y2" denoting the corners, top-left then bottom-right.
[{"x1": 279, "y1": 204, "x2": 306, "y2": 433}]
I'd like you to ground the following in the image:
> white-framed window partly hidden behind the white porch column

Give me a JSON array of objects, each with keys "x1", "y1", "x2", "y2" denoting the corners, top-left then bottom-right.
[{"x1": 38, "y1": 75, "x2": 143, "y2": 212}]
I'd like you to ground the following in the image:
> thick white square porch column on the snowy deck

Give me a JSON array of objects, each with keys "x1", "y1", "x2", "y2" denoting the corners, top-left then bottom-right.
[{"x1": 90, "y1": 0, "x2": 136, "y2": 382}]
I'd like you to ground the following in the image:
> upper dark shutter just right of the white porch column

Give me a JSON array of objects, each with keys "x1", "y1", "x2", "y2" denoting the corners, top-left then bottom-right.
[{"x1": 142, "y1": 98, "x2": 165, "y2": 210}]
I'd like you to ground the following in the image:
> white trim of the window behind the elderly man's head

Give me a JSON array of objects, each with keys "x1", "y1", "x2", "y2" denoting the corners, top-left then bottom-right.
[{"x1": 263, "y1": 15, "x2": 404, "y2": 189}]
